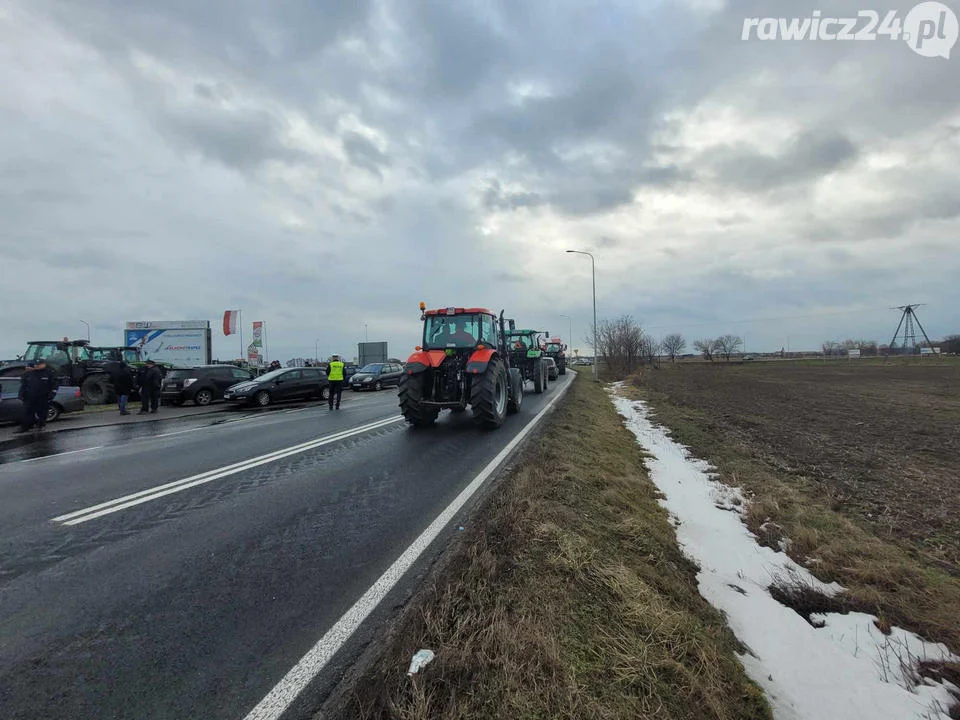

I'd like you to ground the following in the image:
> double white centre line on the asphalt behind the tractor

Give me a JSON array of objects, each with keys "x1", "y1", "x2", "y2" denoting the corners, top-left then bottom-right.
[{"x1": 52, "y1": 415, "x2": 403, "y2": 525}]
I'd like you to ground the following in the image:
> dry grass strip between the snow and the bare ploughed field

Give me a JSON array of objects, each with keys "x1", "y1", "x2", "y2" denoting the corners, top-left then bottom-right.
[{"x1": 624, "y1": 378, "x2": 960, "y2": 671}]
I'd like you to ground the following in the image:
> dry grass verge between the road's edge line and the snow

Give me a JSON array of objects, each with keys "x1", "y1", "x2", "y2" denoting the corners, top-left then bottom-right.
[{"x1": 323, "y1": 378, "x2": 770, "y2": 720}]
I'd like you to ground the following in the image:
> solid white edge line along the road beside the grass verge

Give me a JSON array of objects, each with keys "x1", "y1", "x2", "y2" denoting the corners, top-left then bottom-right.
[{"x1": 245, "y1": 374, "x2": 572, "y2": 720}]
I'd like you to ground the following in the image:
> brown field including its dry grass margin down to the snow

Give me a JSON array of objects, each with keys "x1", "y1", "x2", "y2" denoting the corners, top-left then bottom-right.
[{"x1": 634, "y1": 359, "x2": 960, "y2": 652}]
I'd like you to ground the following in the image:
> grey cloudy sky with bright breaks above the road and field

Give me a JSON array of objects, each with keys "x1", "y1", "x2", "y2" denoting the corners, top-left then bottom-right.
[{"x1": 0, "y1": 0, "x2": 960, "y2": 360}]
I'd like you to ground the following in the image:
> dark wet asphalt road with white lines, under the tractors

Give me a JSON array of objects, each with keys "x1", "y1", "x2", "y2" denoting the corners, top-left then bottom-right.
[{"x1": 0, "y1": 375, "x2": 571, "y2": 720}]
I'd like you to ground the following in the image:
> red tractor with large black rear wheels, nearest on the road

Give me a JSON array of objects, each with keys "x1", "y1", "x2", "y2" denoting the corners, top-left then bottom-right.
[{"x1": 399, "y1": 303, "x2": 523, "y2": 428}]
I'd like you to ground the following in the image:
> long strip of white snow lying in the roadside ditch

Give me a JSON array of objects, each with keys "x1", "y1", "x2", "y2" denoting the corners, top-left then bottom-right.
[{"x1": 613, "y1": 391, "x2": 958, "y2": 720}]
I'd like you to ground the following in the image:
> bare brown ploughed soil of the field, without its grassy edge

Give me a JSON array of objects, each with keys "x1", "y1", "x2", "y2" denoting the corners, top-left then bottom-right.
[{"x1": 642, "y1": 358, "x2": 960, "y2": 576}]
